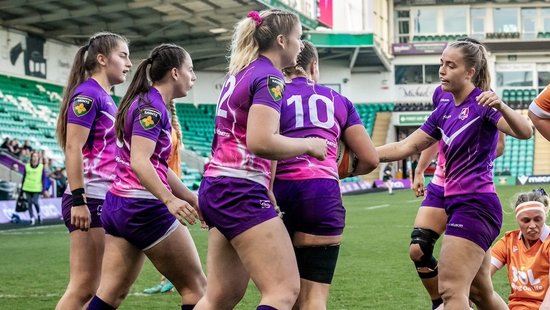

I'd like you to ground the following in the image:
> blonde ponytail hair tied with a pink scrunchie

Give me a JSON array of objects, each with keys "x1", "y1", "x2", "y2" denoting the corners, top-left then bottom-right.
[{"x1": 229, "y1": 10, "x2": 300, "y2": 75}]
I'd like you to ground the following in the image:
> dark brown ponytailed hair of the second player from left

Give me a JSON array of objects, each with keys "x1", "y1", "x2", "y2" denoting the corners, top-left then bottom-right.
[{"x1": 115, "y1": 44, "x2": 189, "y2": 141}]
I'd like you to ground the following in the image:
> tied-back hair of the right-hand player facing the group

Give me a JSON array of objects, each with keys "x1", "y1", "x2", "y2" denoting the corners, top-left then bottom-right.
[{"x1": 449, "y1": 38, "x2": 491, "y2": 90}]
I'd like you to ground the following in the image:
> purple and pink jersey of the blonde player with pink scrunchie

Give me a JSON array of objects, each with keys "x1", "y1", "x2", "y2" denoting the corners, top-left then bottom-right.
[{"x1": 204, "y1": 56, "x2": 285, "y2": 187}]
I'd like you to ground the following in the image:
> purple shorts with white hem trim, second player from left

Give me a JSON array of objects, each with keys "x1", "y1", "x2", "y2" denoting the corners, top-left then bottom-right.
[{"x1": 101, "y1": 192, "x2": 181, "y2": 251}]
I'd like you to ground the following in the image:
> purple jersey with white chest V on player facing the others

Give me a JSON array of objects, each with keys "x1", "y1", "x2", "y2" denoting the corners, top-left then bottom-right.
[{"x1": 421, "y1": 88, "x2": 502, "y2": 197}]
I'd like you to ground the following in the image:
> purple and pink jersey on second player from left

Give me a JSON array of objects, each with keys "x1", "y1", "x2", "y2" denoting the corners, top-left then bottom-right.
[{"x1": 110, "y1": 87, "x2": 172, "y2": 199}]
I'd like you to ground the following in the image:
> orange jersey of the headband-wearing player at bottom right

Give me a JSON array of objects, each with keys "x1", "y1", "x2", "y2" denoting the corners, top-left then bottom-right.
[{"x1": 491, "y1": 225, "x2": 550, "y2": 309}]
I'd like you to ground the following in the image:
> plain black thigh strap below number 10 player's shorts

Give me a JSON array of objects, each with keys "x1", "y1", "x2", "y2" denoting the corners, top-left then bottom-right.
[{"x1": 294, "y1": 245, "x2": 340, "y2": 284}]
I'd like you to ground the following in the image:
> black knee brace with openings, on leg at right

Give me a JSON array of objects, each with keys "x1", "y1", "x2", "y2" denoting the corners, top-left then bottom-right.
[{"x1": 411, "y1": 227, "x2": 439, "y2": 279}]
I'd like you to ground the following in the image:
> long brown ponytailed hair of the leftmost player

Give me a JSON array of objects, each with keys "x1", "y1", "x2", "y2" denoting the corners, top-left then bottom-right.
[{"x1": 56, "y1": 32, "x2": 128, "y2": 150}]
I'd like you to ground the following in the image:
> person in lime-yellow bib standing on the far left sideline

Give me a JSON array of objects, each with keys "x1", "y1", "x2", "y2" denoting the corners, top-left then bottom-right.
[{"x1": 21, "y1": 152, "x2": 48, "y2": 225}]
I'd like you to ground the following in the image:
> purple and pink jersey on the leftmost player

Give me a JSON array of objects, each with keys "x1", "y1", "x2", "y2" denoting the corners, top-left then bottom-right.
[{"x1": 65, "y1": 78, "x2": 117, "y2": 199}]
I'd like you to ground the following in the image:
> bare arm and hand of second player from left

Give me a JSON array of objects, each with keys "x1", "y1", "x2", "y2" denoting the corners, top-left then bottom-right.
[{"x1": 130, "y1": 135, "x2": 199, "y2": 224}]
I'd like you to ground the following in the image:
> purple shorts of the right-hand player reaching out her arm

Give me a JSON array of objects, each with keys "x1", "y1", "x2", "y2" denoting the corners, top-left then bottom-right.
[{"x1": 445, "y1": 193, "x2": 502, "y2": 251}]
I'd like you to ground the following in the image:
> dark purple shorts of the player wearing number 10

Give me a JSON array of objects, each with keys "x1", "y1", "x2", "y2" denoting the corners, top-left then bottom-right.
[{"x1": 273, "y1": 179, "x2": 346, "y2": 236}]
